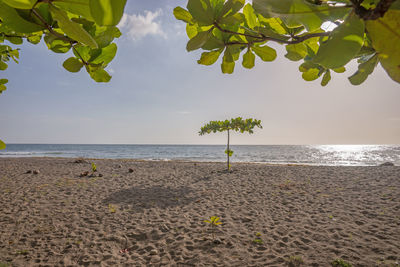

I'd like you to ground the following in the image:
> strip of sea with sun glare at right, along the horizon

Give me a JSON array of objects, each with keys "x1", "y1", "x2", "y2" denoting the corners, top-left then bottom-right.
[{"x1": 0, "y1": 144, "x2": 400, "y2": 166}]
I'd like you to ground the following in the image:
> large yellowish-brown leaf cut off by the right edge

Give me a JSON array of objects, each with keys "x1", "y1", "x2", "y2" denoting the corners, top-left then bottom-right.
[{"x1": 366, "y1": 9, "x2": 400, "y2": 83}]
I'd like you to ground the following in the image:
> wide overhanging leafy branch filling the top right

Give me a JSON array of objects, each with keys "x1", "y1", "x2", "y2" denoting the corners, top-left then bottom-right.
[{"x1": 174, "y1": 0, "x2": 400, "y2": 86}]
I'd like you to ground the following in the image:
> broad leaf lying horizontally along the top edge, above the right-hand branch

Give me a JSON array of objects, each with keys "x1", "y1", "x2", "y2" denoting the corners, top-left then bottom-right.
[{"x1": 253, "y1": 0, "x2": 351, "y2": 31}]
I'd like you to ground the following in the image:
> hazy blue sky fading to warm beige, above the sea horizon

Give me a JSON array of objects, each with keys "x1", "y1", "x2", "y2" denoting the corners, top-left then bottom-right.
[{"x1": 0, "y1": 0, "x2": 400, "y2": 144}]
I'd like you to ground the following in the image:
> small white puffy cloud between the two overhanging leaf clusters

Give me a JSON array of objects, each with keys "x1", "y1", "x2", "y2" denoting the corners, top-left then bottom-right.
[{"x1": 118, "y1": 10, "x2": 167, "y2": 41}]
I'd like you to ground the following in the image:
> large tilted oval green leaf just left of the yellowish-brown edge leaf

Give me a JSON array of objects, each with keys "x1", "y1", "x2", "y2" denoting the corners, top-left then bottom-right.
[{"x1": 313, "y1": 14, "x2": 365, "y2": 69}]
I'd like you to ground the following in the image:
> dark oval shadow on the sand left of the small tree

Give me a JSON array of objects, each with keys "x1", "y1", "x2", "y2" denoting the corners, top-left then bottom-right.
[{"x1": 103, "y1": 186, "x2": 197, "y2": 211}]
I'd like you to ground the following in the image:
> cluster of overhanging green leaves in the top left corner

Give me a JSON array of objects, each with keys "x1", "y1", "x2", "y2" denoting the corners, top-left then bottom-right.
[{"x1": 0, "y1": 0, "x2": 126, "y2": 93}]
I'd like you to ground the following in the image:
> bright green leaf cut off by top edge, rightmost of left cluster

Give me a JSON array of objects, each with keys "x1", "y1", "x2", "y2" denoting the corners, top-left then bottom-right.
[{"x1": 89, "y1": 0, "x2": 126, "y2": 26}]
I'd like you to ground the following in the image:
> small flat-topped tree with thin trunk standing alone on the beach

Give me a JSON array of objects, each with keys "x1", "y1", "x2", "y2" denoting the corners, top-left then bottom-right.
[{"x1": 199, "y1": 117, "x2": 262, "y2": 171}]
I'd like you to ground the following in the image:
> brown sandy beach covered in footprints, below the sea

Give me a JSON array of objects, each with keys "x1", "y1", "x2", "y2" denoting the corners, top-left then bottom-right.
[{"x1": 0, "y1": 158, "x2": 400, "y2": 266}]
